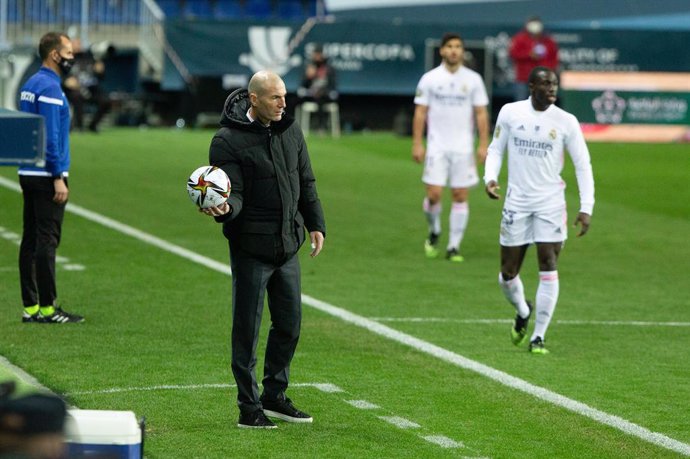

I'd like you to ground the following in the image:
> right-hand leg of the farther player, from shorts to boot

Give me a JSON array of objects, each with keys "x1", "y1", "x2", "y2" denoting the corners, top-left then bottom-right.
[{"x1": 447, "y1": 152, "x2": 479, "y2": 261}]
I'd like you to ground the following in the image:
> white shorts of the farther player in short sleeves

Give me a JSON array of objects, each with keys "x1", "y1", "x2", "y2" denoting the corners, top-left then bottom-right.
[{"x1": 422, "y1": 150, "x2": 479, "y2": 188}]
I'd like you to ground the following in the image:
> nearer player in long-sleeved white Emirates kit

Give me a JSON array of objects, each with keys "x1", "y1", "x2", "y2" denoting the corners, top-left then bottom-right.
[{"x1": 484, "y1": 67, "x2": 594, "y2": 354}]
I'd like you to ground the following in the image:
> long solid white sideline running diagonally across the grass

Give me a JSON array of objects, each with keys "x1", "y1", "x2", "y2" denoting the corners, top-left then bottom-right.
[{"x1": 0, "y1": 176, "x2": 690, "y2": 456}]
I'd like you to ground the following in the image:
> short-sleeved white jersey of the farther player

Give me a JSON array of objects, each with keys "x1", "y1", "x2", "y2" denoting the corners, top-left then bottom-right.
[{"x1": 414, "y1": 64, "x2": 489, "y2": 153}]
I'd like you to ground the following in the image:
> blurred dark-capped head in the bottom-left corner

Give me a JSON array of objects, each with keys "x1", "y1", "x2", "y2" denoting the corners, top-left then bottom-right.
[{"x1": 0, "y1": 381, "x2": 67, "y2": 459}]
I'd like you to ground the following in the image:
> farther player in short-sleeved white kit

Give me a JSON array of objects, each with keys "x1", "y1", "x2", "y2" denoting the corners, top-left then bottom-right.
[{"x1": 412, "y1": 33, "x2": 489, "y2": 262}]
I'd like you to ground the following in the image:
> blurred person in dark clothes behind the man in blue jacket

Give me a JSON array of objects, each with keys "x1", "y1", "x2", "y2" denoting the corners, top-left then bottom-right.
[{"x1": 63, "y1": 38, "x2": 111, "y2": 132}]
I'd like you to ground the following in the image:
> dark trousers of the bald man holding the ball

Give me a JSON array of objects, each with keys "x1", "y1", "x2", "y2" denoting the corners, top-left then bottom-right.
[{"x1": 230, "y1": 244, "x2": 302, "y2": 413}]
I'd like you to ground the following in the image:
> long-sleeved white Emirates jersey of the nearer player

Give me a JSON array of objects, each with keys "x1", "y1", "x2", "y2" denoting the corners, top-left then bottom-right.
[{"x1": 484, "y1": 99, "x2": 594, "y2": 215}]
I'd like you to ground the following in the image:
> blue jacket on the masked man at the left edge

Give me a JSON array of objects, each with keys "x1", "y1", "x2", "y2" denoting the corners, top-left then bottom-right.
[{"x1": 19, "y1": 67, "x2": 70, "y2": 177}]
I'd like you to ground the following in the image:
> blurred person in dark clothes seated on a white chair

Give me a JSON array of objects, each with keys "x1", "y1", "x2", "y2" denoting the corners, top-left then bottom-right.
[{"x1": 297, "y1": 45, "x2": 338, "y2": 128}]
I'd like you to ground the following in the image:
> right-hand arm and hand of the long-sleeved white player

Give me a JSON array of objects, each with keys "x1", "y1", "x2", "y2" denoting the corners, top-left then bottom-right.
[{"x1": 566, "y1": 117, "x2": 594, "y2": 236}]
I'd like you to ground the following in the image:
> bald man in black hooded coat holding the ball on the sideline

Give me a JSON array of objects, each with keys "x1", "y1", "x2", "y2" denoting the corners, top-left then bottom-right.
[{"x1": 204, "y1": 71, "x2": 326, "y2": 428}]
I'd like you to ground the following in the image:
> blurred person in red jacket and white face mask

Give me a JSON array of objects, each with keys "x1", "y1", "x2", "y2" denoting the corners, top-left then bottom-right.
[{"x1": 510, "y1": 16, "x2": 558, "y2": 100}]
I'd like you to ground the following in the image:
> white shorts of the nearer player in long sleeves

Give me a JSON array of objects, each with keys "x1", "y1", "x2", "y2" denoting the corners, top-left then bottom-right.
[{"x1": 500, "y1": 204, "x2": 568, "y2": 247}]
